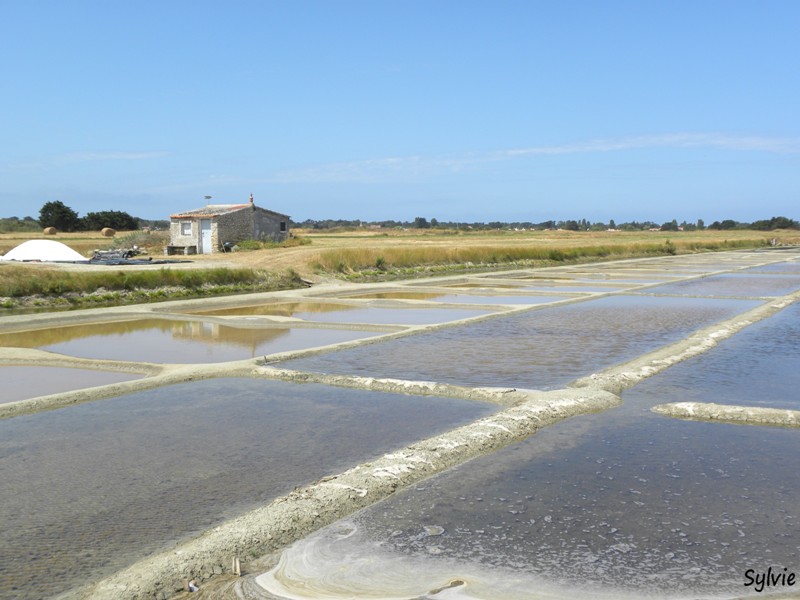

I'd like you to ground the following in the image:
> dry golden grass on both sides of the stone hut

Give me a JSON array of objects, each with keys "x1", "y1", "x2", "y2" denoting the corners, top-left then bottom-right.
[{"x1": 0, "y1": 229, "x2": 800, "y2": 276}]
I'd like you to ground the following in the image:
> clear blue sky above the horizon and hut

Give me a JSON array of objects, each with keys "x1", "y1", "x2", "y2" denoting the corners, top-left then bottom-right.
[{"x1": 0, "y1": 0, "x2": 800, "y2": 223}]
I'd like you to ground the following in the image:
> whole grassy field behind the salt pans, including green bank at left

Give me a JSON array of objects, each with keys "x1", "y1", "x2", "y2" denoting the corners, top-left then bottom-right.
[{"x1": 0, "y1": 229, "x2": 800, "y2": 308}]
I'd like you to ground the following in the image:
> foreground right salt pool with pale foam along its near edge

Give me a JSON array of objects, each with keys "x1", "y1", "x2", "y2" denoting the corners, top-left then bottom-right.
[{"x1": 260, "y1": 364, "x2": 800, "y2": 600}]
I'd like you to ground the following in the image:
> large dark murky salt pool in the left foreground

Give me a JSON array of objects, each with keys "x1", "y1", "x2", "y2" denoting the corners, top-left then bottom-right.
[{"x1": 0, "y1": 379, "x2": 496, "y2": 599}]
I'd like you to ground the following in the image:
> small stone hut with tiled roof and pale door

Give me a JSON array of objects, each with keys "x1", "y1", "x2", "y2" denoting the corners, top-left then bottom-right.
[{"x1": 167, "y1": 196, "x2": 289, "y2": 254}]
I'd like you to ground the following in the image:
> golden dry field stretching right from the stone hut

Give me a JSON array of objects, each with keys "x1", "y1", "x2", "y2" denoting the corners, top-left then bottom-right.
[{"x1": 220, "y1": 229, "x2": 800, "y2": 280}]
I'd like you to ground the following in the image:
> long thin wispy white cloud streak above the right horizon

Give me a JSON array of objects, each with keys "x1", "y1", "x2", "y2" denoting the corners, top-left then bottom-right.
[{"x1": 265, "y1": 133, "x2": 800, "y2": 183}]
